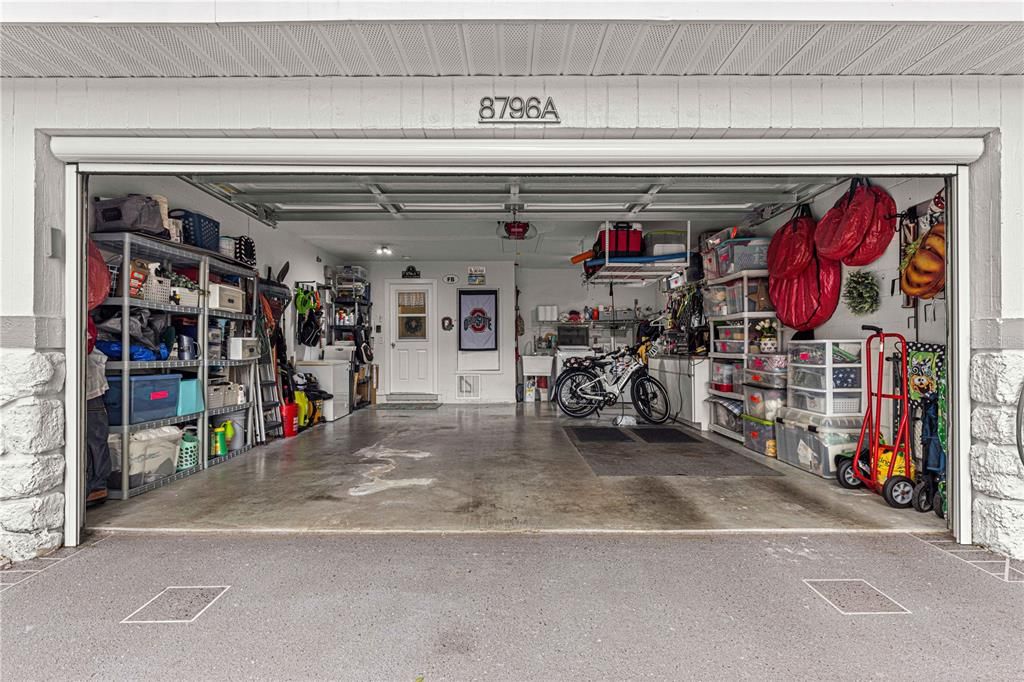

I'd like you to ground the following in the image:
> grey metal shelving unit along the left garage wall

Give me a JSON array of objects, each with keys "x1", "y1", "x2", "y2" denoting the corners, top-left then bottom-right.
[{"x1": 90, "y1": 232, "x2": 258, "y2": 500}]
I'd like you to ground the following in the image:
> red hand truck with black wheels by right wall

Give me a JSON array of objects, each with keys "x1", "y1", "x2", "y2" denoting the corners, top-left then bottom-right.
[{"x1": 836, "y1": 325, "x2": 913, "y2": 509}]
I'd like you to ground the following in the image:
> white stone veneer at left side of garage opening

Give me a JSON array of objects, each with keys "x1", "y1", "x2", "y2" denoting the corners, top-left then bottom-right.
[{"x1": 0, "y1": 348, "x2": 65, "y2": 561}]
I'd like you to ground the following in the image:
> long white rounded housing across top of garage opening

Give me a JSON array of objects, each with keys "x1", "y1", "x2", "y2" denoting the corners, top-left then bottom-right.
[{"x1": 50, "y1": 136, "x2": 984, "y2": 169}]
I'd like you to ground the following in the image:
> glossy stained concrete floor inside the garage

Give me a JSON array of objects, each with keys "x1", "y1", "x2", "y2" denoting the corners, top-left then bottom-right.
[{"x1": 87, "y1": 403, "x2": 944, "y2": 531}]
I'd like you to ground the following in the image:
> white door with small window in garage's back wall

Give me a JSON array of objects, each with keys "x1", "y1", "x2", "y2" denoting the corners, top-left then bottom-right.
[{"x1": 388, "y1": 283, "x2": 437, "y2": 394}]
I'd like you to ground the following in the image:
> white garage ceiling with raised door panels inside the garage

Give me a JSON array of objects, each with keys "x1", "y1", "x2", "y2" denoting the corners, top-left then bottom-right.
[{"x1": 172, "y1": 169, "x2": 844, "y2": 267}]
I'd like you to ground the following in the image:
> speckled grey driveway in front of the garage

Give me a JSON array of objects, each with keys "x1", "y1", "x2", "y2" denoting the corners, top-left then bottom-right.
[{"x1": 0, "y1": 534, "x2": 1024, "y2": 682}]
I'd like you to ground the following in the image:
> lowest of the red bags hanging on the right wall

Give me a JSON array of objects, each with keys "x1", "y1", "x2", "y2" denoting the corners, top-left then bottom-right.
[{"x1": 768, "y1": 255, "x2": 843, "y2": 332}]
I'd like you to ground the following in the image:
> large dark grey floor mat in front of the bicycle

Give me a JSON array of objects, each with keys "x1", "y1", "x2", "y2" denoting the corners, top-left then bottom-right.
[{"x1": 574, "y1": 440, "x2": 782, "y2": 477}]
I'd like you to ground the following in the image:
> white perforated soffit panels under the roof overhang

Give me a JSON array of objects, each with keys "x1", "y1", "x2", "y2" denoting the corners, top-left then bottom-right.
[{"x1": 6, "y1": 22, "x2": 1024, "y2": 78}]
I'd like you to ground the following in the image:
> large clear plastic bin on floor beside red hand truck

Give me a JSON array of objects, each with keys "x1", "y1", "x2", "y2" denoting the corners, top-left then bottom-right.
[{"x1": 775, "y1": 408, "x2": 861, "y2": 478}]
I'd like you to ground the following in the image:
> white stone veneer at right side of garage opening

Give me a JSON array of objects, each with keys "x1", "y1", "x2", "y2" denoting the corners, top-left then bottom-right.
[{"x1": 971, "y1": 350, "x2": 1024, "y2": 558}]
